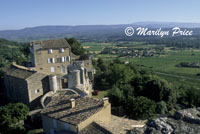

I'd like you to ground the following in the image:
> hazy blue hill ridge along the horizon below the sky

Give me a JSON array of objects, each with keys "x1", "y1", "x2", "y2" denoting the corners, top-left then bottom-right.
[{"x1": 0, "y1": 22, "x2": 200, "y2": 41}]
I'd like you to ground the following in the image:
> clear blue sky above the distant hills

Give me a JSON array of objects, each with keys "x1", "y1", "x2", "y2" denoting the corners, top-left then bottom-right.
[{"x1": 0, "y1": 0, "x2": 200, "y2": 30}]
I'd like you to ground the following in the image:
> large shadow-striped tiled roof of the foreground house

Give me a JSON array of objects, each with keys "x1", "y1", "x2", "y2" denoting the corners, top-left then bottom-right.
[{"x1": 41, "y1": 94, "x2": 103, "y2": 125}]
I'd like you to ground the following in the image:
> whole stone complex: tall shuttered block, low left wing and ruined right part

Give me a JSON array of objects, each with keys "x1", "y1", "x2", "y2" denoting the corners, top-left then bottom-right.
[{"x1": 4, "y1": 39, "x2": 94, "y2": 108}]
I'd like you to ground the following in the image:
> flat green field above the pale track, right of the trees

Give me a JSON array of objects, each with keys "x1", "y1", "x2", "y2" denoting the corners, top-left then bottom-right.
[{"x1": 124, "y1": 51, "x2": 200, "y2": 78}]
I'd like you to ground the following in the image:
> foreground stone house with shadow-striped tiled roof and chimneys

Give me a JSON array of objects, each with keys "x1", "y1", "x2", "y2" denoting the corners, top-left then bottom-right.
[{"x1": 41, "y1": 91, "x2": 111, "y2": 134}]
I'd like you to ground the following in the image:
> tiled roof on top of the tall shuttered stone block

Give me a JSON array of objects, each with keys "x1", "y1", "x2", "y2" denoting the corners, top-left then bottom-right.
[{"x1": 32, "y1": 39, "x2": 70, "y2": 49}]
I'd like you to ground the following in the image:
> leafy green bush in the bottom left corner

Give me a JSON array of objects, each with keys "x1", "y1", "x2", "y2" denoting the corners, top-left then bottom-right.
[{"x1": 0, "y1": 103, "x2": 29, "y2": 134}]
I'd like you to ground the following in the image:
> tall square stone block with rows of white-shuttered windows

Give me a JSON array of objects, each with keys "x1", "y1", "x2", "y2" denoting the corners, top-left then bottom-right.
[{"x1": 30, "y1": 39, "x2": 72, "y2": 75}]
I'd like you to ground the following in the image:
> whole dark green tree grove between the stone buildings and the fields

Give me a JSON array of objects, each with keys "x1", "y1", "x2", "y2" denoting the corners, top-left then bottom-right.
[{"x1": 93, "y1": 59, "x2": 200, "y2": 119}]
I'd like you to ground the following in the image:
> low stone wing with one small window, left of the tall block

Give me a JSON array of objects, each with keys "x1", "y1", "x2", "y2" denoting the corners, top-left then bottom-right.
[{"x1": 4, "y1": 64, "x2": 49, "y2": 108}]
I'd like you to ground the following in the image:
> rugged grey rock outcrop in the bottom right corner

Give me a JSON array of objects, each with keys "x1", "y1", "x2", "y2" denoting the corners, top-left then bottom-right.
[{"x1": 128, "y1": 108, "x2": 200, "y2": 134}]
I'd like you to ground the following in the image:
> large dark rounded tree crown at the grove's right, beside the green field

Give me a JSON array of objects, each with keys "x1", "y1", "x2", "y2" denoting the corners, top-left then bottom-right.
[{"x1": 132, "y1": 75, "x2": 176, "y2": 109}]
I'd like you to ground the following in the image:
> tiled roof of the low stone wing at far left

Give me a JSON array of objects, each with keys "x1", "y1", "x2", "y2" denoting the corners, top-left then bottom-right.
[{"x1": 4, "y1": 65, "x2": 36, "y2": 79}]
